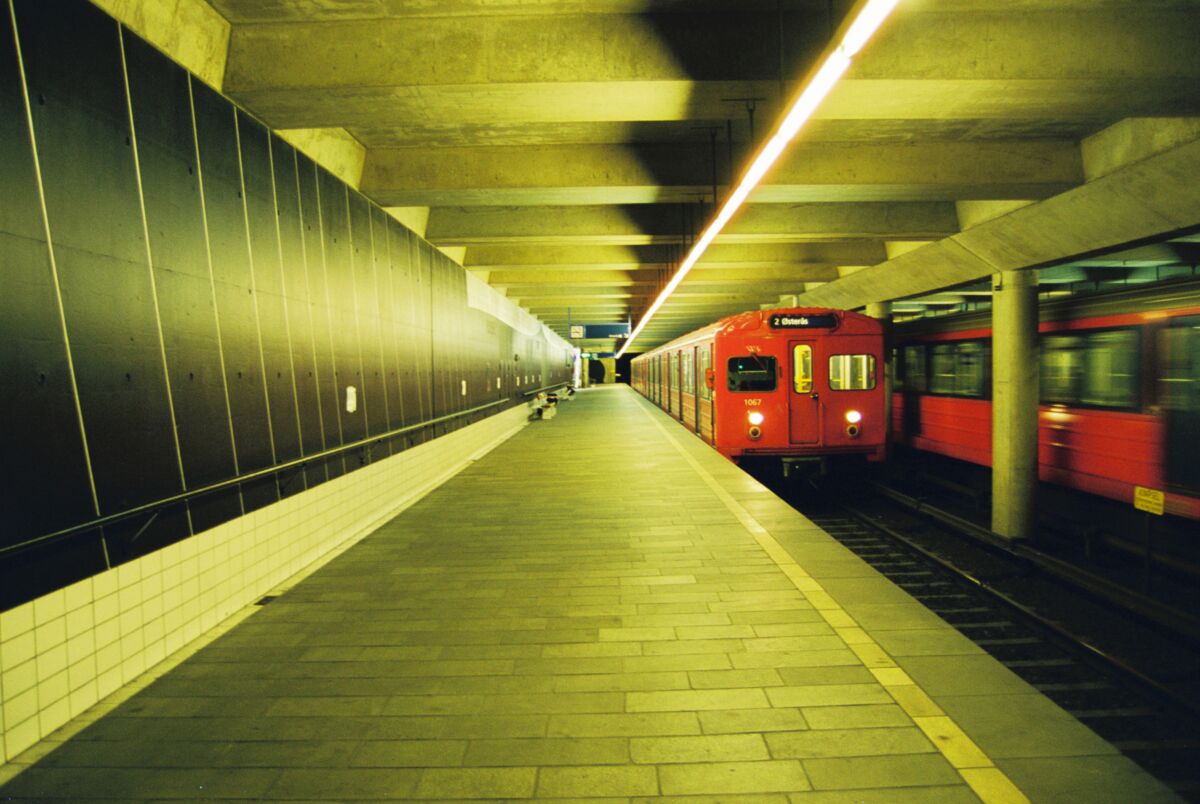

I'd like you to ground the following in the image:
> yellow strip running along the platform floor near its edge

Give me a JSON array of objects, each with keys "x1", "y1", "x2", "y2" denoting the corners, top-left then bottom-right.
[{"x1": 641, "y1": 403, "x2": 1030, "y2": 804}]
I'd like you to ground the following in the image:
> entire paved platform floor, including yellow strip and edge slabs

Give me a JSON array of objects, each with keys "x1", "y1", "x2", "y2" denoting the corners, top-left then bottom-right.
[{"x1": 0, "y1": 386, "x2": 1175, "y2": 804}]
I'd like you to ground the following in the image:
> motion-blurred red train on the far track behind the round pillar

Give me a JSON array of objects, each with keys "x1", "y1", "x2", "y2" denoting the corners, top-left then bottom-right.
[{"x1": 892, "y1": 281, "x2": 1200, "y2": 520}]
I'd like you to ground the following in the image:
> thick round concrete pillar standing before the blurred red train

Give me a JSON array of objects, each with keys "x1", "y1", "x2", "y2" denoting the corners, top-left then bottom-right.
[{"x1": 991, "y1": 270, "x2": 1039, "y2": 540}]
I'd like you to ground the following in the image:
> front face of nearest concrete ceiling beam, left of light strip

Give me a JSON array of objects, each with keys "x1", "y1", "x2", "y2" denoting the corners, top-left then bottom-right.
[{"x1": 226, "y1": 10, "x2": 811, "y2": 92}]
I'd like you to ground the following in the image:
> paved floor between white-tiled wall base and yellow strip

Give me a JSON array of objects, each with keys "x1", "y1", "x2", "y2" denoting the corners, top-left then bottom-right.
[{"x1": 5, "y1": 388, "x2": 1003, "y2": 800}]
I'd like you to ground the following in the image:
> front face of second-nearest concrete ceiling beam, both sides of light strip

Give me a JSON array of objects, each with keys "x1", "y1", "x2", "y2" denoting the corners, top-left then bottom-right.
[{"x1": 362, "y1": 140, "x2": 1084, "y2": 206}]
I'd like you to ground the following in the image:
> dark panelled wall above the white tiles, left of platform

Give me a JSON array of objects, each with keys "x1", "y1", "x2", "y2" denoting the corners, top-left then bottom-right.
[{"x1": 0, "y1": 0, "x2": 569, "y2": 608}]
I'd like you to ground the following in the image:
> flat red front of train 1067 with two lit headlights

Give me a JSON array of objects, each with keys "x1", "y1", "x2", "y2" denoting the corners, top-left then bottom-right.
[{"x1": 709, "y1": 308, "x2": 887, "y2": 466}]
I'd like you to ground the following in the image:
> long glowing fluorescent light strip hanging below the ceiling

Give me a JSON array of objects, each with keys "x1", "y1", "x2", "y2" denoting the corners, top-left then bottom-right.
[{"x1": 617, "y1": 0, "x2": 900, "y2": 358}]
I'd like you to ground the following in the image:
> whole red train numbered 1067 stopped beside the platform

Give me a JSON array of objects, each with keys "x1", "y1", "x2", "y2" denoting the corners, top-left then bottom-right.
[{"x1": 631, "y1": 308, "x2": 887, "y2": 470}]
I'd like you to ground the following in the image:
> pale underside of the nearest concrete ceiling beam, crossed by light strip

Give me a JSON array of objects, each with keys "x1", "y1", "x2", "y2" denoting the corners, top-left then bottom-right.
[{"x1": 230, "y1": 77, "x2": 1200, "y2": 133}]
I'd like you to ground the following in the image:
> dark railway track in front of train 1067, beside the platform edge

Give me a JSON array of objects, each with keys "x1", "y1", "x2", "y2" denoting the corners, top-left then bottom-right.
[{"x1": 792, "y1": 494, "x2": 1200, "y2": 802}]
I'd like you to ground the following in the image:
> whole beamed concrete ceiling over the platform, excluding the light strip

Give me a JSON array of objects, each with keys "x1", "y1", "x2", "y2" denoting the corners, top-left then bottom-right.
[{"x1": 201, "y1": 0, "x2": 1200, "y2": 350}]
